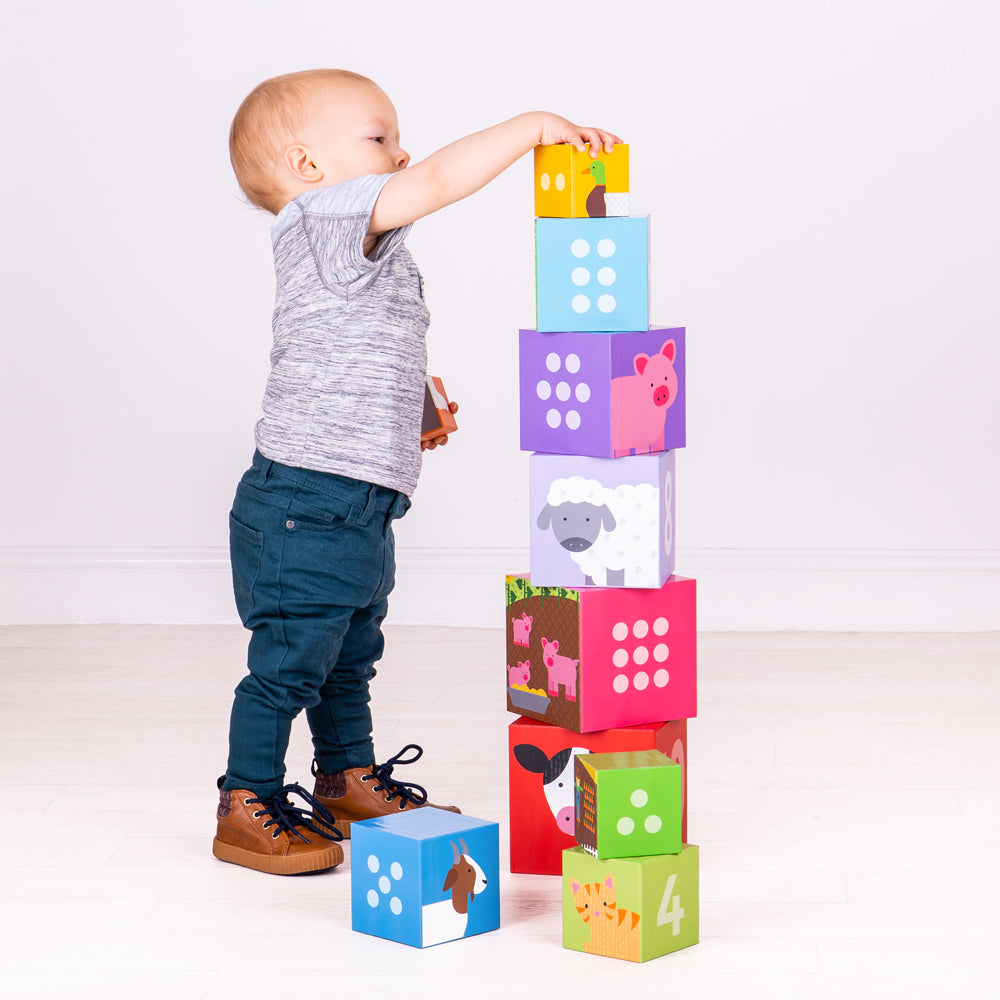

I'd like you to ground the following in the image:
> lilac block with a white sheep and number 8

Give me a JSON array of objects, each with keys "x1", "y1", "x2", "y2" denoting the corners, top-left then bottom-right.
[{"x1": 528, "y1": 451, "x2": 676, "y2": 588}]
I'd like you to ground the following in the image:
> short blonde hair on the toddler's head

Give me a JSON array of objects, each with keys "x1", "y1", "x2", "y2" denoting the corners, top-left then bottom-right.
[{"x1": 229, "y1": 69, "x2": 376, "y2": 215}]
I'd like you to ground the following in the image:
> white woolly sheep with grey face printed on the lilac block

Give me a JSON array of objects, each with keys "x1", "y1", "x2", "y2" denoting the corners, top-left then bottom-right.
[{"x1": 536, "y1": 473, "x2": 673, "y2": 587}]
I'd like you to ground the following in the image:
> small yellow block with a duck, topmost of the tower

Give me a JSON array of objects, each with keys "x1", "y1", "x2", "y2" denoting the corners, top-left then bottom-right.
[{"x1": 535, "y1": 143, "x2": 628, "y2": 219}]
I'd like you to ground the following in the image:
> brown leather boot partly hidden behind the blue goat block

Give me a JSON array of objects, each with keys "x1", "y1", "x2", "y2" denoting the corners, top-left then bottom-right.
[{"x1": 312, "y1": 743, "x2": 462, "y2": 839}]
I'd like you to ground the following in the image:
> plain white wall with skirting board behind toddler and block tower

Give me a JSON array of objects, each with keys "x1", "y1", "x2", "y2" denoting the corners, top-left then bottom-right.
[{"x1": 0, "y1": 0, "x2": 1000, "y2": 628}]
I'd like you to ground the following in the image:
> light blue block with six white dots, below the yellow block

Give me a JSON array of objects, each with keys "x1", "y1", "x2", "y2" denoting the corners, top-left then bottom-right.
[{"x1": 535, "y1": 217, "x2": 649, "y2": 332}]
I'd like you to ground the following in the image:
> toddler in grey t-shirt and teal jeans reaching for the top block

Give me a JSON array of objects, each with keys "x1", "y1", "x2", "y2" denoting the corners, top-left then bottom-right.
[{"x1": 213, "y1": 70, "x2": 621, "y2": 875}]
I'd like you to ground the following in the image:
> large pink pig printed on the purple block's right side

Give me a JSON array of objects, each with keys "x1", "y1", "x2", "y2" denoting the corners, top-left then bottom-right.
[{"x1": 611, "y1": 340, "x2": 677, "y2": 458}]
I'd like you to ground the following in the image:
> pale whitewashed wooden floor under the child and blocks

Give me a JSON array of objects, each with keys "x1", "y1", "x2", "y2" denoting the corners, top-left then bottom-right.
[{"x1": 0, "y1": 626, "x2": 1000, "y2": 1000}]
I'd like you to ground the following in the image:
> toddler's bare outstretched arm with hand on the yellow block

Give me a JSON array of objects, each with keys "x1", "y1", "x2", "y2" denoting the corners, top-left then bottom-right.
[{"x1": 368, "y1": 111, "x2": 622, "y2": 233}]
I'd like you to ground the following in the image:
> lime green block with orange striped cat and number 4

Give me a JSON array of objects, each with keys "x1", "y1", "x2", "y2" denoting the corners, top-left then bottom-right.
[{"x1": 563, "y1": 844, "x2": 698, "y2": 962}]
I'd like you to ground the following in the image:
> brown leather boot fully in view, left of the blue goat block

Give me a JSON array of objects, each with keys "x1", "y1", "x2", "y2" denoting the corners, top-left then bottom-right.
[{"x1": 212, "y1": 778, "x2": 344, "y2": 875}]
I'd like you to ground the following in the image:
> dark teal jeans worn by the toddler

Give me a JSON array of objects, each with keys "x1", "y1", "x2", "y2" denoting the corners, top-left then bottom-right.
[{"x1": 222, "y1": 452, "x2": 410, "y2": 798}]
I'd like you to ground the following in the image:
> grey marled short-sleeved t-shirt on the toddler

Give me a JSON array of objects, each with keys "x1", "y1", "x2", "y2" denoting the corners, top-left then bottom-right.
[{"x1": 256, "y1": 174, "x2": 430, "y2": 496}]
